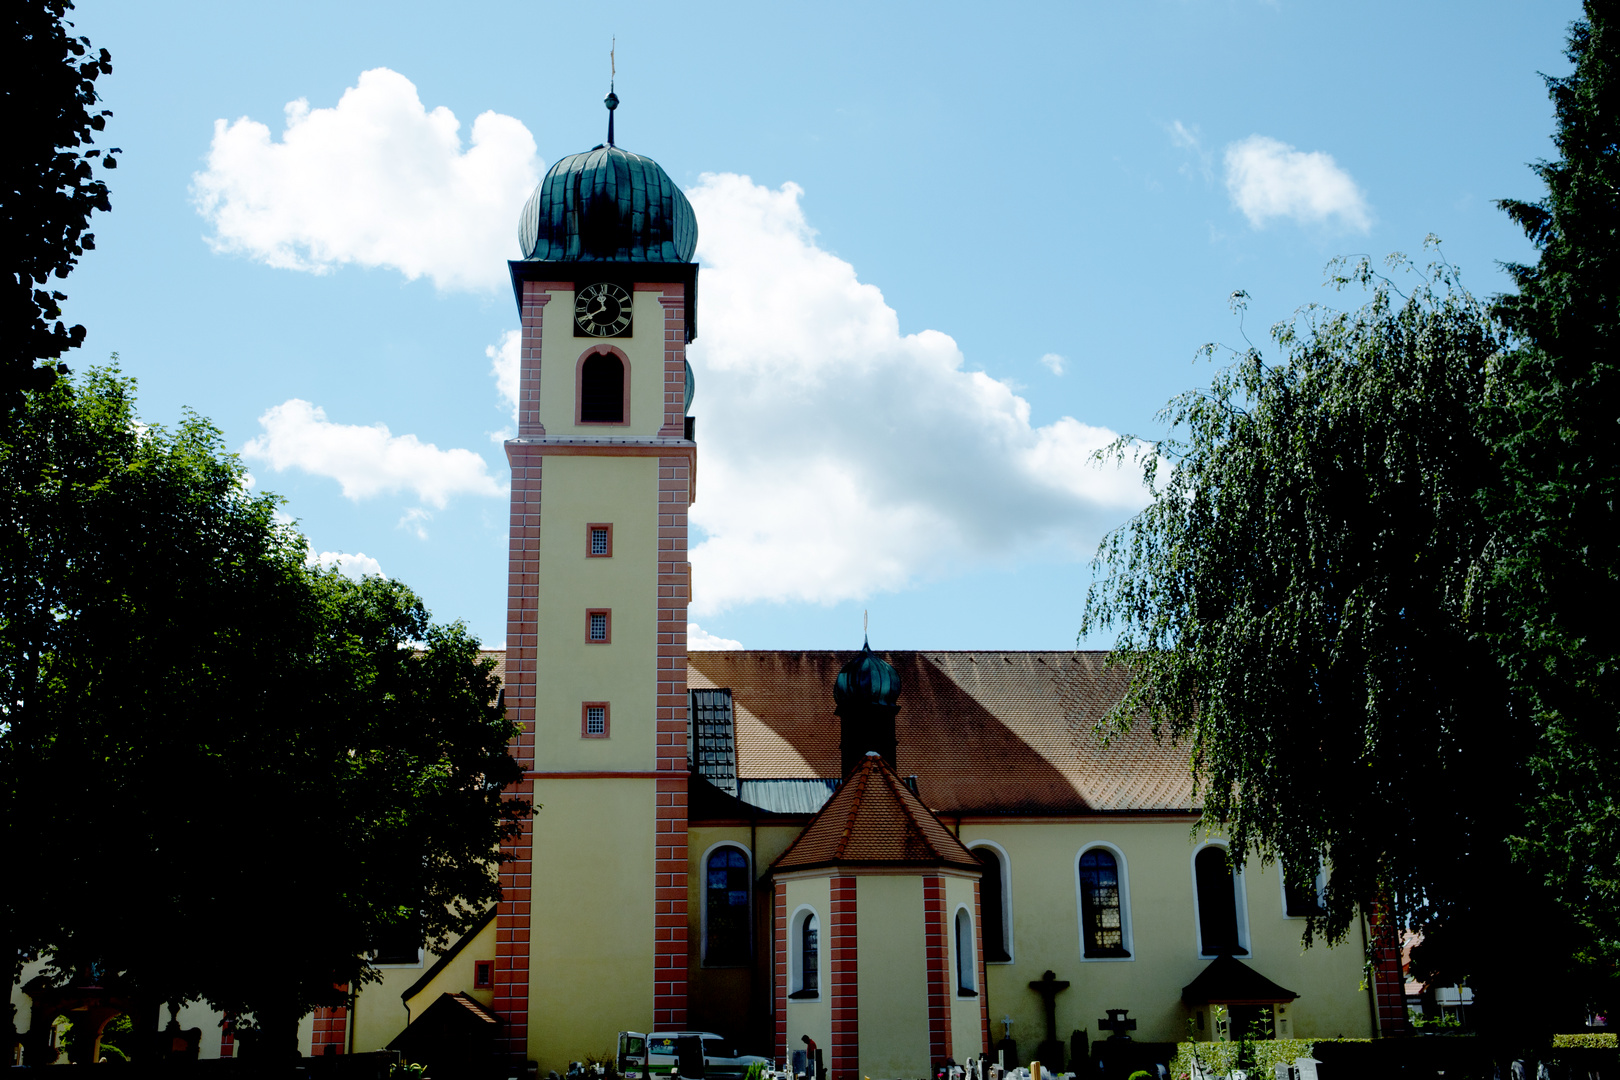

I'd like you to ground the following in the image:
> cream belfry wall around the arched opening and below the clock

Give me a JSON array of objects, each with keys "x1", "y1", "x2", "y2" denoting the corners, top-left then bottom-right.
[{"x1": 539, "y1": 285, "x2": 680, "y2": 439}]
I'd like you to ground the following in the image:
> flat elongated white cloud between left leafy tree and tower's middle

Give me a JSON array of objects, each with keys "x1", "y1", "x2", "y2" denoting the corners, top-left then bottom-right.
[{"x1": 241, "y1": 398, "x2": 505, "y2": 508}]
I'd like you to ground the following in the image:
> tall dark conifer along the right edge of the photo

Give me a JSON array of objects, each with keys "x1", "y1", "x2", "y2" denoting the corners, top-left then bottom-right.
[{"x1": 1487, "y1": 0, "x2": 1620, "y2": 1001}]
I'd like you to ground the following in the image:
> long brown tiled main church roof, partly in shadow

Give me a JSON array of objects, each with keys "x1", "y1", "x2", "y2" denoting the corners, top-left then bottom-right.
[{"x1": 687, "y1": 649, "x2": 1194, "y2": 814}]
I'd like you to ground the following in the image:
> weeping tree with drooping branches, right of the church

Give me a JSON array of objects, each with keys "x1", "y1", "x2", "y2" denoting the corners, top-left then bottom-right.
[{"x1": 1084, "y1": 250, "x2": 1587, "y2": 1030}]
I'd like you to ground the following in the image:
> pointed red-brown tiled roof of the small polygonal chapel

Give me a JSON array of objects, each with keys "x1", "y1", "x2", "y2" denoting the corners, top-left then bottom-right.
[{"x1": 771, "y1": 755, "x2": 978, "y2": 871}]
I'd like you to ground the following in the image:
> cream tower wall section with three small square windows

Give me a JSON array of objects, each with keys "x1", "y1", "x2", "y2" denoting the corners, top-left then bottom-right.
[{"x1": 535, "y1": 455, "x2": 658, "y2": 773}]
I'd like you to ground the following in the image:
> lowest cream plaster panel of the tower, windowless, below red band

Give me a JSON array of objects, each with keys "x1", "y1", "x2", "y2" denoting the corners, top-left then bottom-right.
[{"x1": 528, "y1": 774, "x2": 656, "y2": 1075}]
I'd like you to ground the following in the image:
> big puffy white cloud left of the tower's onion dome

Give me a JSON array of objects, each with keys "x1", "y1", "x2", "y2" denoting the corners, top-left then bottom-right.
[{"x1": 191, "y1": 68, "x2": 541, "y2": 290}]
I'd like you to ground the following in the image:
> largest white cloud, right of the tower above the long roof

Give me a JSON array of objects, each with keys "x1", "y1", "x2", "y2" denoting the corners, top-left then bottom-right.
[{"x1": 689, "y1": 175, "x2": 1144, "y2": 615}]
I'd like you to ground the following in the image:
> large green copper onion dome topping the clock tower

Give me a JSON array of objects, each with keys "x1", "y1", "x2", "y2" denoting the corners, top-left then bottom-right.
[{"x1": 517, "y1": 91, "x2": 698, "y2": 262}]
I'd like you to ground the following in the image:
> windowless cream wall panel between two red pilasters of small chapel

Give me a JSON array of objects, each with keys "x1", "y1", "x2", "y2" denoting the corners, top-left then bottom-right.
[{"x1": 855, "y1": 874, "x2": 930, "y2": 1078}]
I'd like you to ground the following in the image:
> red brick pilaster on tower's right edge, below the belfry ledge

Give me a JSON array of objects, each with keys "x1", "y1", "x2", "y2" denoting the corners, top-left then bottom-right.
[{"x1": 653, "y1": 455, "x2": 692, "y2": 1030}]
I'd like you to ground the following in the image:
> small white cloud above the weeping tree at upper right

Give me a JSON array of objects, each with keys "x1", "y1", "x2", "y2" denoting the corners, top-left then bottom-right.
[{"x1": 1226, "y1": 134, "x2": 1372, "y2": 232}]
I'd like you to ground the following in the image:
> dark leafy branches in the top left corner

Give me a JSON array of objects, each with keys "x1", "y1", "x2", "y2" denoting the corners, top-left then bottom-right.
[{"x1": 0, "y1": 0, "x2": 118, "y2": 411}]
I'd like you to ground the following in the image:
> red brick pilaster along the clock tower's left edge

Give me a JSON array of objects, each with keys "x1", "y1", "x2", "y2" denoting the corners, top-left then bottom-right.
[{"x1": 492, "y1": 433, "x2": 544, "y2": 1061}]
